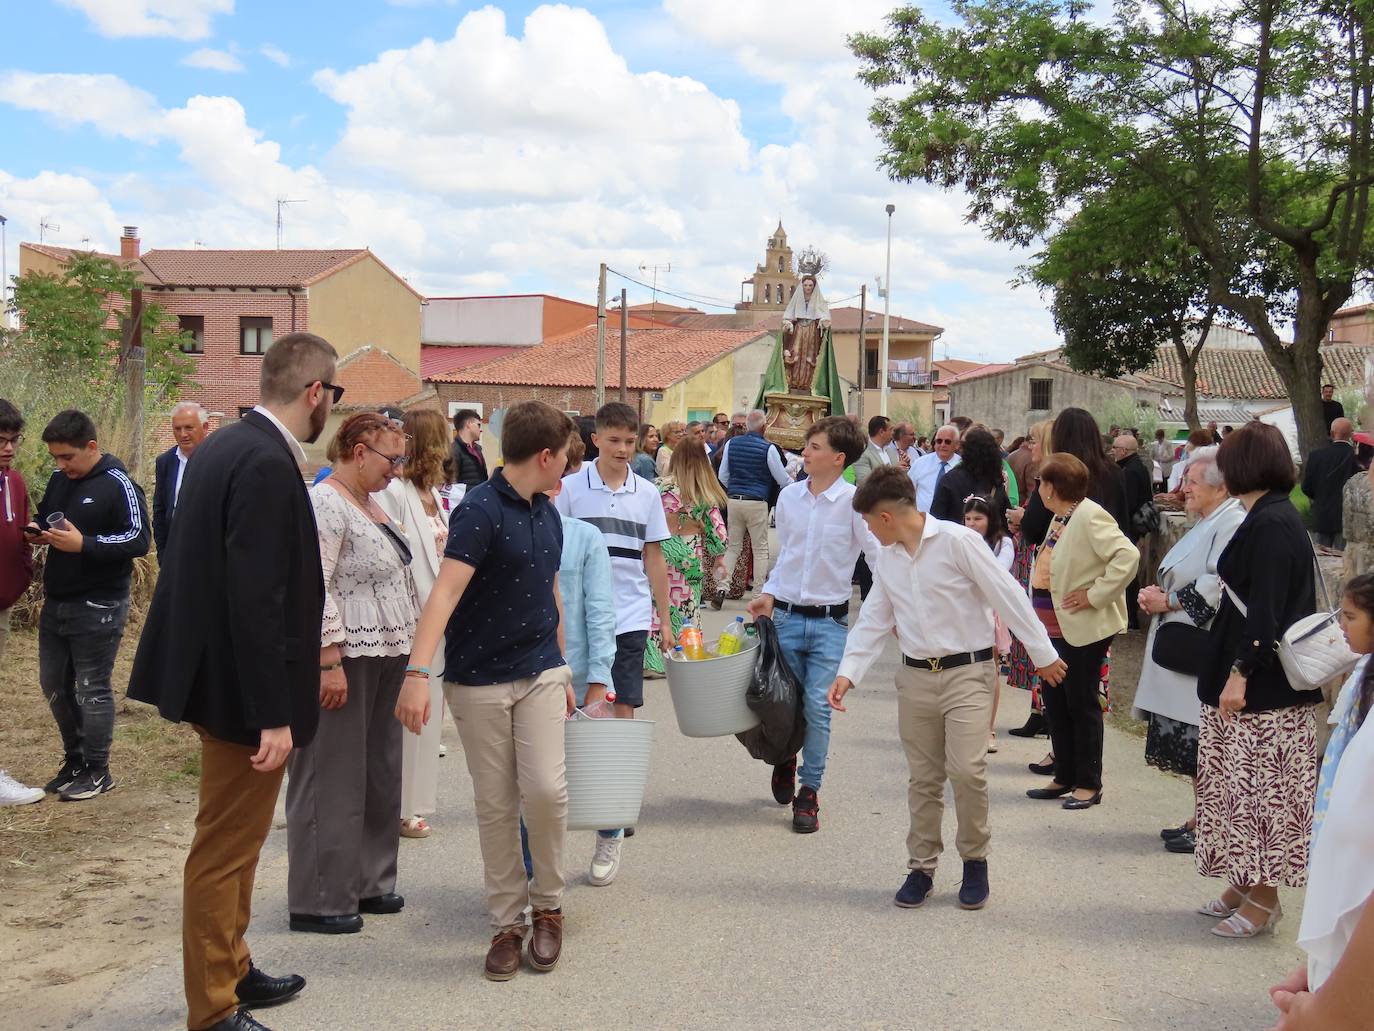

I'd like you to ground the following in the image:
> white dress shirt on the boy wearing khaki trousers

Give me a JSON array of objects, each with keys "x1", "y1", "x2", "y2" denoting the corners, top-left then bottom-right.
[{"x1": 840, "y1": 517, "x2": 1058, "y2": 683}]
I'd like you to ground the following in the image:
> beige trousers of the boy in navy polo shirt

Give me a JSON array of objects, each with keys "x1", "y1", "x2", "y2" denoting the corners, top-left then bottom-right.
[{"x1": 444, "y1": 665, "x2": 572, "y2": 929}]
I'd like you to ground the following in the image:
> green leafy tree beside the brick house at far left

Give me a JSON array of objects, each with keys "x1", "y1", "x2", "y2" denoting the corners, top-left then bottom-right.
[{"x1": 14, "y1": 254, "x2": 191, "y2": 393}]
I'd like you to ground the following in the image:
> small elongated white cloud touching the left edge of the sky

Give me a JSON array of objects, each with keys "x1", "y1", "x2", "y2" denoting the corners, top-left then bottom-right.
[{"x1": 0, "y1": 71, "x2": 161, "y2": 142}]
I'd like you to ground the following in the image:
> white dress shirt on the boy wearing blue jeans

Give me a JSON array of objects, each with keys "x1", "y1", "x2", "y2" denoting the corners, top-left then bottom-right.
[{"x1": 763, "y1": 478, "x2": 879, "y2": 605}]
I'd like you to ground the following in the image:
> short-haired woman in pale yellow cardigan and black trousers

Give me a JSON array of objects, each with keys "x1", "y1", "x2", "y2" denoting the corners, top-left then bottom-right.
[{"x1": 1026, "y1": 452, "x2": 1140, "y2": 810}]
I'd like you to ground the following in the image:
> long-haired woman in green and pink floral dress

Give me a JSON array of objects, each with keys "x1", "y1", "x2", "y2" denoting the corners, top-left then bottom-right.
[{"x1": 644, "y1": 437, "x2": 725, "y2": 674}]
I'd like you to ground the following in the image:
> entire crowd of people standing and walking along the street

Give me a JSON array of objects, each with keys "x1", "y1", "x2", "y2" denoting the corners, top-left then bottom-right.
[{"x1": 0, "y1": 340, "x2": 1374, "y2": 1031}]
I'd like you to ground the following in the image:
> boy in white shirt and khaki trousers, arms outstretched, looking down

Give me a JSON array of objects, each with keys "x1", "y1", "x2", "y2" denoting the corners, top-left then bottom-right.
[{"x1": 830, "y1": 466, "x2": 1066, "y2": 909}]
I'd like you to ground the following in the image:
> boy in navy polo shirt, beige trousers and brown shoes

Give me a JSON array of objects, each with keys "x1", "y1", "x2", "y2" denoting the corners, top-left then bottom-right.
[{"x1": 396, "y1": 401, "x2": 573, "y2": 982}]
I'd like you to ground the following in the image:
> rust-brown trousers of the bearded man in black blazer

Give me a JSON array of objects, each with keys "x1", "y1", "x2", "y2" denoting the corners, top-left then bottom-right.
[{"x1": 181, "y1": 727, "x2": 286, "y2": 1028}]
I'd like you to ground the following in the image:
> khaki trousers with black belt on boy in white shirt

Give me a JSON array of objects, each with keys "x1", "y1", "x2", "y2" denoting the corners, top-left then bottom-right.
[{"x1": 897, "y1": 660, "x2": 996, "y2": 873}]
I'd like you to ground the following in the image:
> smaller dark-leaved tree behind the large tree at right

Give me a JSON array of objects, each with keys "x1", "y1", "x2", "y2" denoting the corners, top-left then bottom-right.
[{"x1": 1025, "y1": 181, "x2": 1216, "y2": 429}]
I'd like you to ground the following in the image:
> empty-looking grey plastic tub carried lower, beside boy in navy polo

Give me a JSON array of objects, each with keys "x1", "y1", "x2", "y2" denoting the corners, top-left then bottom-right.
[{"x1": 563, "y1": 713, "x2": 654, "y2": 830}]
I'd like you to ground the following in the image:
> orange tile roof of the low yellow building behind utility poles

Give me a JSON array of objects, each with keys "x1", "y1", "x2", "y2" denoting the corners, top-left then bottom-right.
[{"x1": 429, "y1": 327, "x2": 771, "y2": 390}]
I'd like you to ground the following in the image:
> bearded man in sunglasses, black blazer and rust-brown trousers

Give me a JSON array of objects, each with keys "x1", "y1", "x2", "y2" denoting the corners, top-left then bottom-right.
[{"x1": 129, "y1": 333, "x2": 344, "y2": 1031}]
